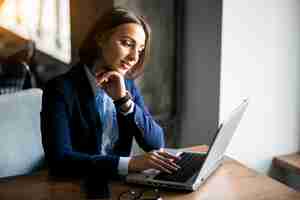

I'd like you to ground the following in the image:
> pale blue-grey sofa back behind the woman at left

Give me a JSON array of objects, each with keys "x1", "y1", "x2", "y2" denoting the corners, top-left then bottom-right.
[{"x1": 0, "y1": 88, "x2": 45, "y2": 178}]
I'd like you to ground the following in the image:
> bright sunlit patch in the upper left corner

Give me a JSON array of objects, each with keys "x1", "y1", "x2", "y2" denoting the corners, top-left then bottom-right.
[{"x1": 0, "y1": 0, "x2": 71, "y2": 63}]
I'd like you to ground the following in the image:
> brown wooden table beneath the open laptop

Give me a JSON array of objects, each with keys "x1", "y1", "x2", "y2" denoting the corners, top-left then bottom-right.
[{"x1": 0, "y1": 146, "x2": 300, "y2": 200}]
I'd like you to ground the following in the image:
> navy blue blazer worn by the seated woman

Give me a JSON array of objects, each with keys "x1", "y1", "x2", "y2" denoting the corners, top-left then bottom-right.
[{"x1": 41, "y1": 64, "x2": 164, "y2": 176}]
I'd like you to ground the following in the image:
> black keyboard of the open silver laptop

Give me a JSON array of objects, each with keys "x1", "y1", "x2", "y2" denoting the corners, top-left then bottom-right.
[{"x1": 154, "y1": 152, "x2": 206, "y2": 182}]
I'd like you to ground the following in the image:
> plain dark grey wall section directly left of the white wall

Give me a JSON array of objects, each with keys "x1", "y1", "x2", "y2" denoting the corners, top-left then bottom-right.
[{"x1": 177, "y1": 0, "x2": 222, "y2": 146}]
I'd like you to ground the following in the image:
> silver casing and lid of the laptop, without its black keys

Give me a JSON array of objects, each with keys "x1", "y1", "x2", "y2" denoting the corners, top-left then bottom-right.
[{"x1": 126, "y1": 100, "x2": 248, "y2": 191}]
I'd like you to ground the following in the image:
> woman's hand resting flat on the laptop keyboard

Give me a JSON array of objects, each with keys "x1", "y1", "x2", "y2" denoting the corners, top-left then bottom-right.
[{"x1": 128, "y1": 149, "x2": 180, "y2": 174}]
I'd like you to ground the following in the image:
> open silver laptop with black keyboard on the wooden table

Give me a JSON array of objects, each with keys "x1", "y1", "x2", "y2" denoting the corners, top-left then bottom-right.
[{"x1": 126, "y1": 100, "x2": 248, "y2": 191}]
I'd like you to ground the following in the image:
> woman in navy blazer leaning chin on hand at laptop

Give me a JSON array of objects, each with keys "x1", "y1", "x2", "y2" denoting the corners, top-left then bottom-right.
[{"x1": 41, "y1": 8, "x2": 179, "y2": 176}]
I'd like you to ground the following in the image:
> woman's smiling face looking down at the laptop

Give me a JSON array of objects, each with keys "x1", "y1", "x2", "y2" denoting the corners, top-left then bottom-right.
[{"x1": 99, "y1": 23, "x2": 146, "y2": 75}]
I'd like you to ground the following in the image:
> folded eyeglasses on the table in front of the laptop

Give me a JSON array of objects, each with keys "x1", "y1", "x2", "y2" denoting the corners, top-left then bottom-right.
[{"x1": 119, "y1": 189, "x2": 162, "y2": 200}]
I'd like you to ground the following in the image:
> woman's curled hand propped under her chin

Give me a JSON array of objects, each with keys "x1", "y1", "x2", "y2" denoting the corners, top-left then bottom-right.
[{"x1": 96, "y1": 71, "x2": 126, "y2": 100}]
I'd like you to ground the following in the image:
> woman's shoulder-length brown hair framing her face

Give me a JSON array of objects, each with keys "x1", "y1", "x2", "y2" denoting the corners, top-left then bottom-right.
[{"x1": 79, "y1": 7, "x2": 151, "y2": 79}]
